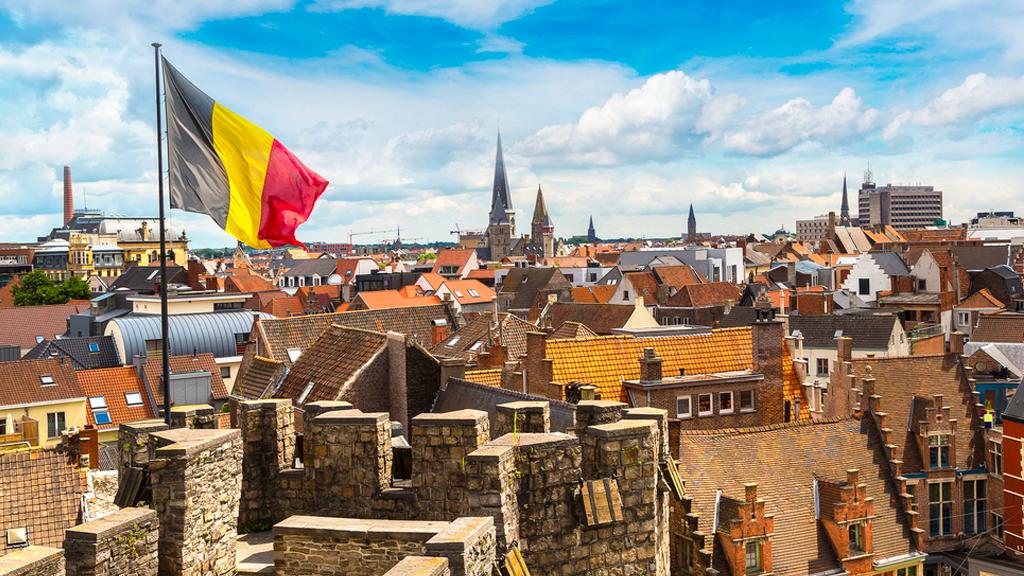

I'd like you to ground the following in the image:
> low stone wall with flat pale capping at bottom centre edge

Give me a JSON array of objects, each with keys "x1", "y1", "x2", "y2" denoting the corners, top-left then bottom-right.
[{"x1": 273, "y1": 516, "x2": 495, "y2": 576}]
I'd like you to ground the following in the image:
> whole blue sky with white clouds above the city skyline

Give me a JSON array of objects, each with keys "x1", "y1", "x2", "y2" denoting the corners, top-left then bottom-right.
[{"x1": 0, "y1": 0, "x2": 1024, "y2": 246}]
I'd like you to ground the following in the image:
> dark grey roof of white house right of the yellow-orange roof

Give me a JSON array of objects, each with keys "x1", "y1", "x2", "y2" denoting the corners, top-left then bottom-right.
[{"x1": 790, "y1": 316, "x2": 899, "y2": 351}]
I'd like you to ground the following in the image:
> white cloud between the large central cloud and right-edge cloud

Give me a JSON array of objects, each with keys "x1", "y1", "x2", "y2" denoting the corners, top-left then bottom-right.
[{"x1": 723, "y1": 87, "x2": 878, "y2": 156}]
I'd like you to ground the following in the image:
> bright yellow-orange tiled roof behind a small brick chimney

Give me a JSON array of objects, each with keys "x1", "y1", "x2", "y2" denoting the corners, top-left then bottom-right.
[{"x1": 547, "y1": 326, "x2": 754, "y2": 402}]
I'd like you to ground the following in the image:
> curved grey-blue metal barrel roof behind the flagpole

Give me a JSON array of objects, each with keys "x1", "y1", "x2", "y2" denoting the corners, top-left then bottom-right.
[{"x1": 111, "y1": 311, "x2": 273, "y2": 359}]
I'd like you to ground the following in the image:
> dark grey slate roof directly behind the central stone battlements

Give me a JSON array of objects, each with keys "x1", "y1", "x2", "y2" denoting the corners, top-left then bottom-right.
[{"x1": 430, "y1": 378, "x2": 575, "y2": 431}]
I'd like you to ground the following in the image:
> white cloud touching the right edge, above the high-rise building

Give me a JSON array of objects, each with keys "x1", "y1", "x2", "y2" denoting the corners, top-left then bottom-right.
[{"x1": 885, "y1": 73, "x2": 1024, "y2": 138}]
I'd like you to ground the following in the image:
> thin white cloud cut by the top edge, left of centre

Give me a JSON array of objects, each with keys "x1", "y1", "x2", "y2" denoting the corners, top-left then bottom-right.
[{"x1": 309, "y1": 0, "x2": 553, "y2": 30}]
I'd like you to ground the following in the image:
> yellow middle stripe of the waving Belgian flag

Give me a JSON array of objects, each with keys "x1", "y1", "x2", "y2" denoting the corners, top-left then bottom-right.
[{"x1": 213, "y1": 102, "x2": 273, "y2": 248}]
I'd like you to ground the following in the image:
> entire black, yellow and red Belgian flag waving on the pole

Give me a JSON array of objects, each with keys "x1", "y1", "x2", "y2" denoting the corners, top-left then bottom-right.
[{"x1": 164, "y1": 58, "x2": 328, "y2": 248}]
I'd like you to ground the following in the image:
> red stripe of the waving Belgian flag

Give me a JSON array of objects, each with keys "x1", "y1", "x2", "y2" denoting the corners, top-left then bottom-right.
[{"x1": 259, "y1": 139, "x2": 328, "y2": 247}]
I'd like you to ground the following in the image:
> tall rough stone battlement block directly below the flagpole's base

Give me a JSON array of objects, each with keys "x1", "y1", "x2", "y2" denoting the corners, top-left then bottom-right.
[{"x1": 150, "y1": 428, "x2": 242, "y2": 576}]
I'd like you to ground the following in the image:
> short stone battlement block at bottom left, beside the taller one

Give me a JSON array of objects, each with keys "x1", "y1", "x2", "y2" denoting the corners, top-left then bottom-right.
[{"x1": 63, "y1": 508, "x2": 160, "y2": 576}]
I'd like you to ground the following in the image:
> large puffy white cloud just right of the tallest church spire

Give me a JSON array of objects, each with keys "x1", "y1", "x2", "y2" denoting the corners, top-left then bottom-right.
[{"x1": 515, "y1": 71, "x2": 742, "y2": 165}]
